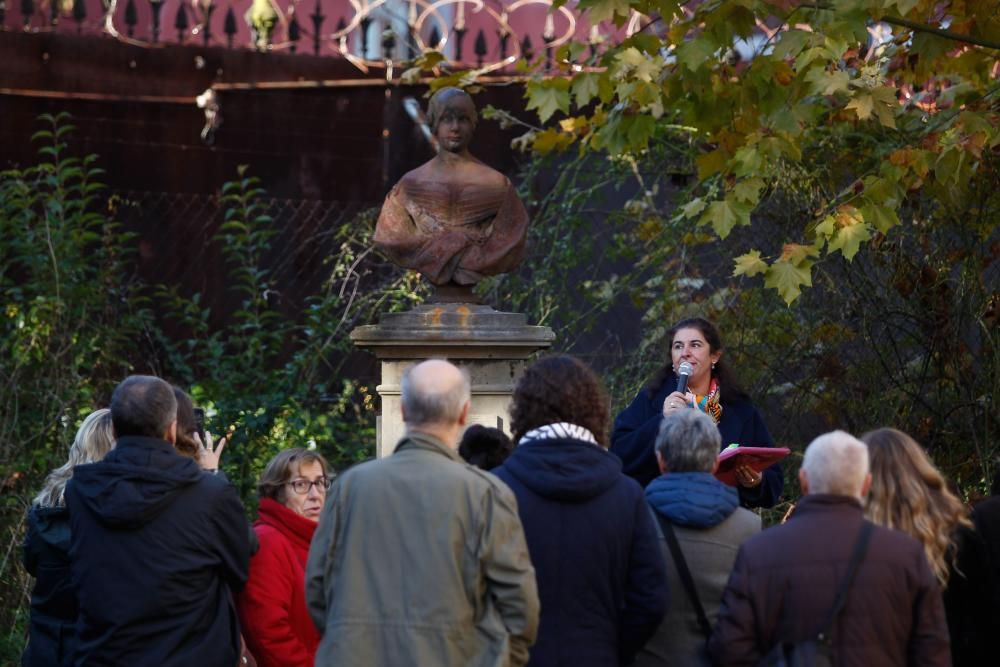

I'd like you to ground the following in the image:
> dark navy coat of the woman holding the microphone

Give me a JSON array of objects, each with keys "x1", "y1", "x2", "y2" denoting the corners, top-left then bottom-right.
[{"x1": 611, "y1": 378, "x2": 784, "y2": 507}]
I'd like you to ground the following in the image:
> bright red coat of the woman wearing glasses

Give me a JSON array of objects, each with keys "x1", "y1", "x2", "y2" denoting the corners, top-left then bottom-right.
[{"x1": 237, "y1": 498, "x2": 319, "y2": 667}]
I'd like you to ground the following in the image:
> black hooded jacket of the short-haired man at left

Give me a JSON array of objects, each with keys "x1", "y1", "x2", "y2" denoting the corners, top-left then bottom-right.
[{"x1": 66, "y1": 436, "x2": 250, "y2": 667}]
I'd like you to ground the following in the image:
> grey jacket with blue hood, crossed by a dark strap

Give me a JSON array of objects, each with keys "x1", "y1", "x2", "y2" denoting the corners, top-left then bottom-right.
[{"x1": 635, "y1": 472, "x2": 760, "y2": 667}]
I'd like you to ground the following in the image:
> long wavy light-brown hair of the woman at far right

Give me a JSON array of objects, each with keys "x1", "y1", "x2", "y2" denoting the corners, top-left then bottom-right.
[{"x1": 861, "y1": 428, "x2": 972, "y2": 588}]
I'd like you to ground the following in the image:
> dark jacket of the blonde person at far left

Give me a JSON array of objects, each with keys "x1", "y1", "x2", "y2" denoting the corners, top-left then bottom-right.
[{"x1": 21, "y1": 505, "x2": 77, "y2": 667}]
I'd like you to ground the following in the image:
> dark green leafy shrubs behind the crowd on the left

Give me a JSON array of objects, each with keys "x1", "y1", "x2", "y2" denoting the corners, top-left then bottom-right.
[{"x1": 0, "y1": 116, "x2": 423, "y2": 664}]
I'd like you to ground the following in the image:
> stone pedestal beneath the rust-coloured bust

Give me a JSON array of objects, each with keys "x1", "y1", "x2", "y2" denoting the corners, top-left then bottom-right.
[{"x1": 351, "y1": 303, "x2": 555, "y2": 457}]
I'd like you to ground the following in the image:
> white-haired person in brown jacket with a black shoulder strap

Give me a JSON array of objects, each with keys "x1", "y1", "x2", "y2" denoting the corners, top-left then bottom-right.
[{"x1": 709, "y1": 431, "x2": 951, "y2": 667}]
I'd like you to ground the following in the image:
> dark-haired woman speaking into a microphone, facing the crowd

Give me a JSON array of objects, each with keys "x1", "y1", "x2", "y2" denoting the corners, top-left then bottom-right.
[{"x1": 611, "y1": 317, "x2": 784, "y2": 507}]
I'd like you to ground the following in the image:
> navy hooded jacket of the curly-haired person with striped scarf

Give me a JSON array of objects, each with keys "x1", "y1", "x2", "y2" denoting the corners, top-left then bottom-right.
[{"x1": 493, "y1": 439, "x2": 667, "y2": 667}]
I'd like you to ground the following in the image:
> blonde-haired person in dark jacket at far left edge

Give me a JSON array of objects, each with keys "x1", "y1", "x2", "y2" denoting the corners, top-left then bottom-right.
[{"x1": 21, "y1": 408, "x2": 115, "y2": 667}]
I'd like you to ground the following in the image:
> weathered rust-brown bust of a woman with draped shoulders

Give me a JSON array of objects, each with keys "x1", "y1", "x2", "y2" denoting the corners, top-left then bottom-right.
[{"x1": 375, "y1": 88, "x2": 528, "y2": 287}]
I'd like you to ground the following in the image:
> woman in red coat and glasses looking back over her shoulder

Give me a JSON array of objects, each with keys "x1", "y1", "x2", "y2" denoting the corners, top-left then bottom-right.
[{"x1": 238, "y1": 448, "x2": 330, "y2": 667}]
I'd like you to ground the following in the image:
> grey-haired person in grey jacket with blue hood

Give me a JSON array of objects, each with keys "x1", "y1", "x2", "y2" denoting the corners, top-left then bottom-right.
[{"x1": 633, "y1": 410, "x2": 760, "y2": 667}]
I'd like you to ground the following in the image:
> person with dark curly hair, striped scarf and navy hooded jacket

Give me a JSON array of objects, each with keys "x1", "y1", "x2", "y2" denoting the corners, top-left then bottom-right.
[{"x1": 492, "y1": 356, "x2": 667, "y2": 667}]
